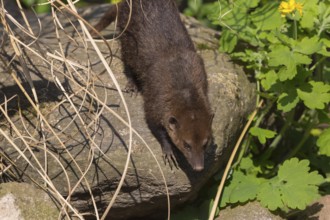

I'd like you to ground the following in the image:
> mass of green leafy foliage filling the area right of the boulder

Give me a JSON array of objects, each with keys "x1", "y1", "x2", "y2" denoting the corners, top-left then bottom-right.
[{"x1": 22, "y1": 0, "x2": 330, "y2": 219}]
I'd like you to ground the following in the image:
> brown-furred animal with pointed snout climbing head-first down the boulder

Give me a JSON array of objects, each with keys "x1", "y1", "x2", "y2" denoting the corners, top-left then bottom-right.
[{"x1": 96, "y1": 0, "x2": 212, "y2": 171}]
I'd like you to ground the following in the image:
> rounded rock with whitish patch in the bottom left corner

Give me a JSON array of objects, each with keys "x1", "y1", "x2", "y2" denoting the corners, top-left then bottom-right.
[{"x1": 0, "y1": 182, "x2": 59, "y2": 220}]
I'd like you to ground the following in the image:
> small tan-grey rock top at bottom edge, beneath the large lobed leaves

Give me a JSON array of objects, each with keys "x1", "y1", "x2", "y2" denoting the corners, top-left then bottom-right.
[{"x1": 216, "y1": 202, "x2": 283, "y2": 220}]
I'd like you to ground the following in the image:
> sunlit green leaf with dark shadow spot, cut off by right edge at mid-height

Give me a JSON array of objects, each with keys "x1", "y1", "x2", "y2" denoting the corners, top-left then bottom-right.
[{"x1": 297, "y1": 81, "x2": 330, "y2": 109}]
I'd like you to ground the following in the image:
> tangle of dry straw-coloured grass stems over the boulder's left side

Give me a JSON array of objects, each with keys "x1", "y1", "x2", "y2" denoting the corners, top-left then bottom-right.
[{"x1": 0, "y1": 0, "x2": 170, "y2": 219}]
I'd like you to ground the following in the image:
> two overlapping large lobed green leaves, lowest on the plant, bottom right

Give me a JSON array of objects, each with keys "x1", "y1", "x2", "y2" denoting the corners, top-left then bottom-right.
[{"x1": 221, "y1": 158, "x2": 324, "y2": 211}]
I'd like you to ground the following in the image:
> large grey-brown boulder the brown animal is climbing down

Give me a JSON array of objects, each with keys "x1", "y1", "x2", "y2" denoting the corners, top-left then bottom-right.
[{"x1": 0, "y1": 5, "x2": 255, "y2": 219}]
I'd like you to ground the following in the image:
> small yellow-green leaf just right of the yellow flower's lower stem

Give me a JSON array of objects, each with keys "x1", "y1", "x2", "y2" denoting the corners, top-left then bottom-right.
[{"x1": 294, "y1": 36, "x2": 322, "y2": 55}]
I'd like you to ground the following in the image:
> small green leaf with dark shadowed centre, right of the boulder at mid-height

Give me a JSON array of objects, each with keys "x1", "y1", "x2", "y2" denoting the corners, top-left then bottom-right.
[{"x1": 277, "y1": 88, "x2": 299, "y2": 112}]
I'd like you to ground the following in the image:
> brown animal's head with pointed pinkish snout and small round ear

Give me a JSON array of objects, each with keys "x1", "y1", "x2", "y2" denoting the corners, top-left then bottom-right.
[{"x1": 166, "y1": 110, "x2": 213, "y2": 171}]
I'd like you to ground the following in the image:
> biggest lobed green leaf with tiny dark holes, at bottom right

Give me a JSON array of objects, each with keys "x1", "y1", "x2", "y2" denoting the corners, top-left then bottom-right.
[{"x1": 257, "y1": 158, "x2": 324, "y2": 210}]
